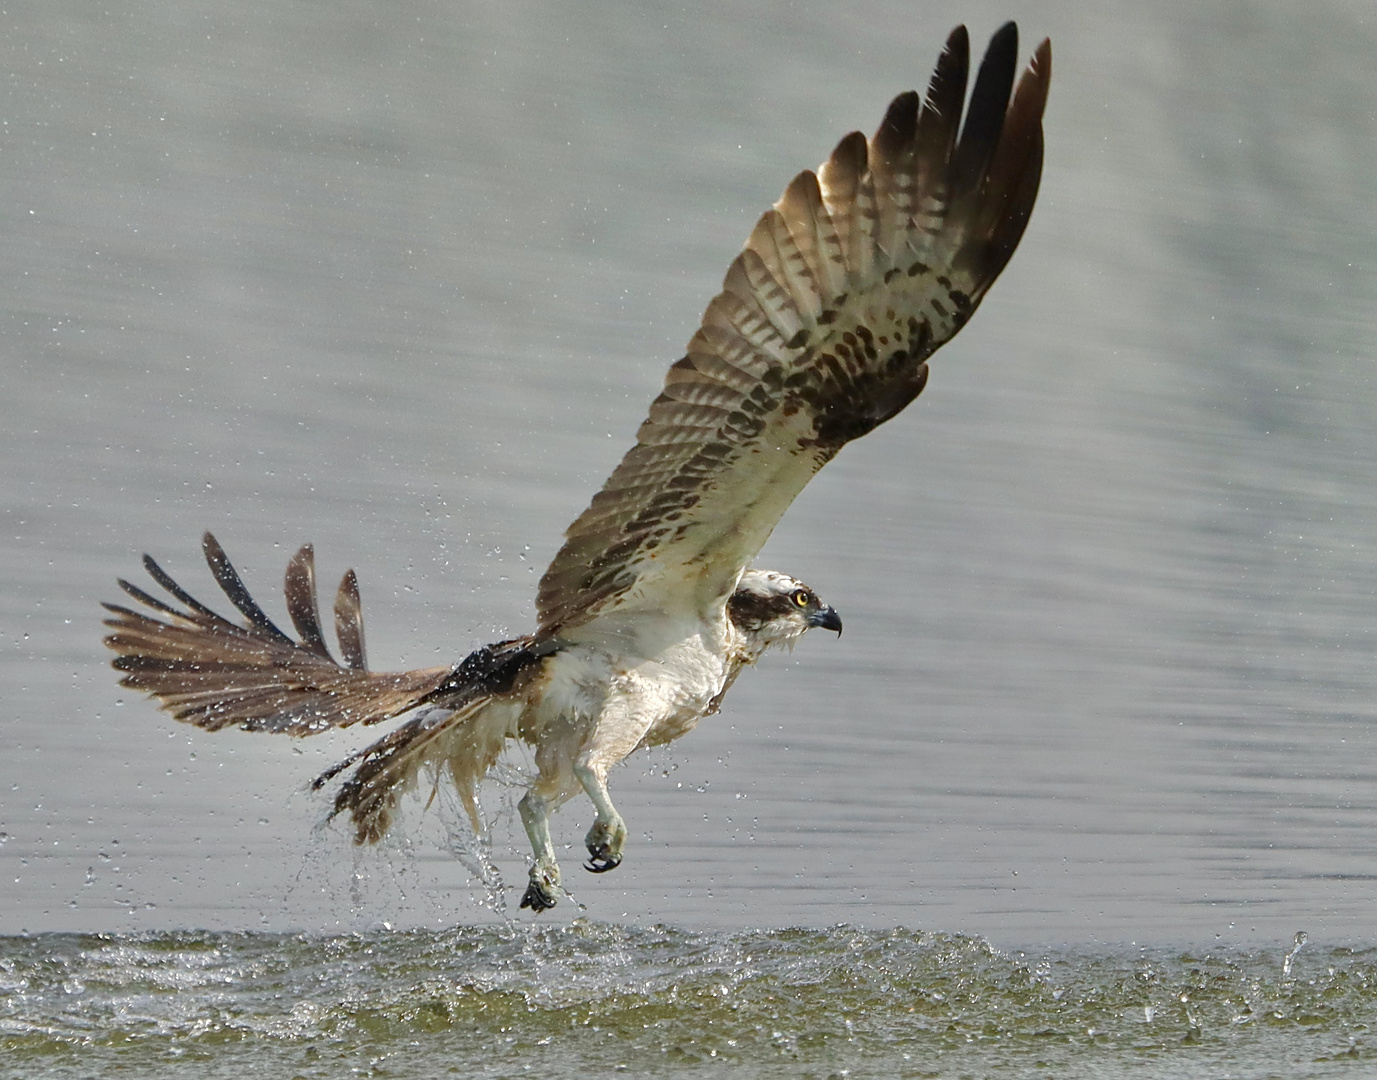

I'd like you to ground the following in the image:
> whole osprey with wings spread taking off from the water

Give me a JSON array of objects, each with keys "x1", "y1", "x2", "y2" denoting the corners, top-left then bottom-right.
[{"x1": 105, "y1": 22, "x2": 1052, "y2": 911}]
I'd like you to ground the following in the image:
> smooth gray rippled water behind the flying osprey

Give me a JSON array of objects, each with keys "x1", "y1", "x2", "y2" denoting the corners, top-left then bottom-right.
[{"x1": 0, "y1": 0, "x2": 1377, "y2": 946}]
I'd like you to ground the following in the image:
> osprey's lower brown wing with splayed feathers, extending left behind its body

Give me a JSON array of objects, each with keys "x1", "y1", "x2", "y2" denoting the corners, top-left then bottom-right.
[{"x1": 102, "y1": 533, "x2": 463, "y2": 736}]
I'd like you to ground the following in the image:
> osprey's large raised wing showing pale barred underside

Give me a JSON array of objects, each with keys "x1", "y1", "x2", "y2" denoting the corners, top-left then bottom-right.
[{"x1": 537, "y1": 22, "x2": 1052, "y2": 636}]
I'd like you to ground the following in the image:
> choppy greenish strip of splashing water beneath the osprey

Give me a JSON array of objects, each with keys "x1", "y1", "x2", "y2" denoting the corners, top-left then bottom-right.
[{"x1": 0, "y1": 922, "x2": 1377, "y2": 1077}]
